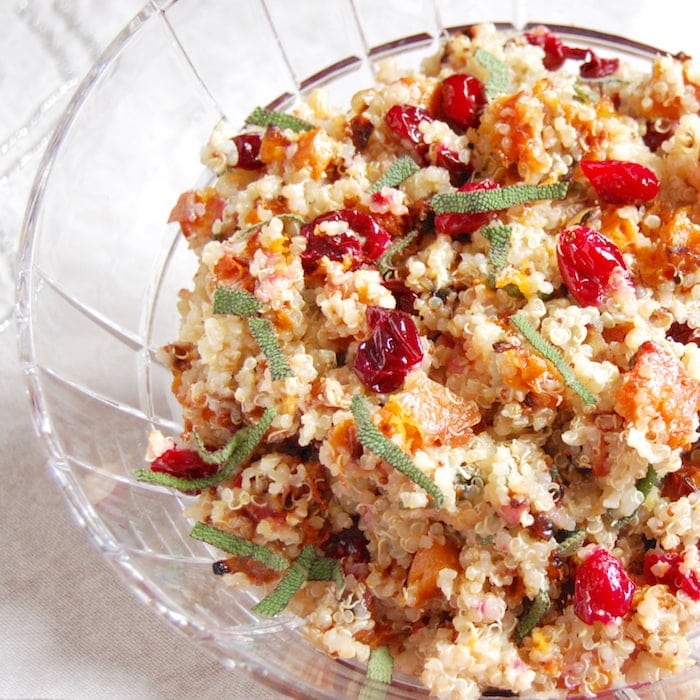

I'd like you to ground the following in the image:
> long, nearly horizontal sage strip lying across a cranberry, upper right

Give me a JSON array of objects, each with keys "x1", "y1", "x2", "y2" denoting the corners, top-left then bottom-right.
[{"x1": 432, "y1": 182, "x2": 569, "y2": 214}]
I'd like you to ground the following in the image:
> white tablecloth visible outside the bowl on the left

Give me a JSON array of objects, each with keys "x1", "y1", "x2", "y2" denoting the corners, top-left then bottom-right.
[{"x1": 0, "y1": 0, "x2": 276, "y2": 699}]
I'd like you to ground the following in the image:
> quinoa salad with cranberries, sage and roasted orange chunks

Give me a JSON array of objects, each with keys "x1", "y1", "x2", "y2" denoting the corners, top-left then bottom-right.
[{"x1": 137, "y1": 24, "x2": 700, "y2": 698}]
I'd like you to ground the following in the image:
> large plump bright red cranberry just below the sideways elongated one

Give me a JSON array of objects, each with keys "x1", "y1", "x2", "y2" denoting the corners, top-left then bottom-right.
[{"x1": 557, "y1": 226, "x2": 631, "y2": 306}]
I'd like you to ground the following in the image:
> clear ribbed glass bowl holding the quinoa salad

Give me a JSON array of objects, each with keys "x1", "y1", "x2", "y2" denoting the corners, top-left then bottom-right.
[{"x1": 16, "y1": 0, "x2": 700, "y2": 700}]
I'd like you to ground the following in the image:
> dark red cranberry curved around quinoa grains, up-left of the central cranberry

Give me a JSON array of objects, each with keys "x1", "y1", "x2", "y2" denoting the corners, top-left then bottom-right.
[{"x1": 301, "y1": 209, "x2": 391, "y2": 272}]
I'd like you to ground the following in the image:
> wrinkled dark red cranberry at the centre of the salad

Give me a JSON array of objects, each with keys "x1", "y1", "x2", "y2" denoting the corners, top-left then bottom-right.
[{"x1": 353, "y1": 306, "x2": 423, "y2": 394}]
